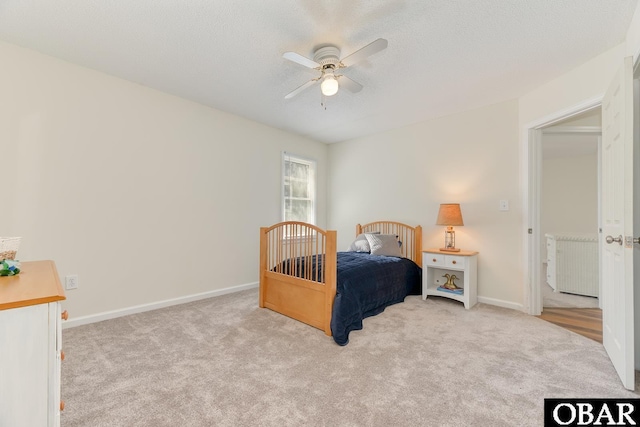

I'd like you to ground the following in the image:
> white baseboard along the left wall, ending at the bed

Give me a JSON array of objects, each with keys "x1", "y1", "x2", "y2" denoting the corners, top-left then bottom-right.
[{"x1": 62, "y1": 282, "x2": 259, "y2": 329}]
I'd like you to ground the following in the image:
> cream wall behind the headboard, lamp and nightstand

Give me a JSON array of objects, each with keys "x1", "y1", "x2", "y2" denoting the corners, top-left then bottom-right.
[{"x1": 328, "y1": 101, "x2": 523, "y2": 307}]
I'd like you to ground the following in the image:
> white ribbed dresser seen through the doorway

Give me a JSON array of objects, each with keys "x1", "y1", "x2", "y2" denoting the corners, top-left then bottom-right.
[{"x1": 545, "y1": 233, "x2": 600, "y2": 297}]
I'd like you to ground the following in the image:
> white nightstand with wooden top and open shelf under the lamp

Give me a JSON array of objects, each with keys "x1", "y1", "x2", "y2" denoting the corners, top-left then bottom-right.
[{"x1": 422, "y1": 249, "x2": 478, "y2": 309}]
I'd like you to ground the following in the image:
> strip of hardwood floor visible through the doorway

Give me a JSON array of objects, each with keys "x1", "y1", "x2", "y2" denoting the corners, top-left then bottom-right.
[{"x1": 537, "y1": 307, "x2": 602, "y2": 343}]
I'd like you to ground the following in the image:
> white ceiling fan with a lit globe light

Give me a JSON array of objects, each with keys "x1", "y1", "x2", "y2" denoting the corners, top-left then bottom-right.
[{"x1": 282, "y1": 39, "x2": 388, "y2": 99}]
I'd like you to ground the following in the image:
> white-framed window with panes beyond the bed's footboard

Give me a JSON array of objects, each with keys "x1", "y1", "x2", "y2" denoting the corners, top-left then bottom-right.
[{"x1": 282, "y1": 152, "x2": 316, "y2": 224}]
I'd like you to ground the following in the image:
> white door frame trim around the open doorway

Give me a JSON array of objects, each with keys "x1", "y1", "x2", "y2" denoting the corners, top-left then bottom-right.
[{"x1": 521, "y1": 98, "x2": 604, "y2": 316}]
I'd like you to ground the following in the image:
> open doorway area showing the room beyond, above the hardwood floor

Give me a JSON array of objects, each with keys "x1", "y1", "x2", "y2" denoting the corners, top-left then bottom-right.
[{"x1": 538, "y1": 113, "x2": 602, "y2": 310}]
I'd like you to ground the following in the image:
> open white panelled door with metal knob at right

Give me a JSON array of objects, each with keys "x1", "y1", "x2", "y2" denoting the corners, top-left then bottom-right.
[{"x1": 600, "y1": 57, "x2": 635, "y2": 390}]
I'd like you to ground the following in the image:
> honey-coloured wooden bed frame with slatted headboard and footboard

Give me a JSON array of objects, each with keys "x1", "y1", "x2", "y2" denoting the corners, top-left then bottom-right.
[{"x1": 260, "y1": 221, "x2": 422, "y2": 336}]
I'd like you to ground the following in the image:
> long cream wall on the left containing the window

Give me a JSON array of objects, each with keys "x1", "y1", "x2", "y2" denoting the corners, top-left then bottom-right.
[{"x1": 0, "y1": 43, "x2": 328, "y2": 317}]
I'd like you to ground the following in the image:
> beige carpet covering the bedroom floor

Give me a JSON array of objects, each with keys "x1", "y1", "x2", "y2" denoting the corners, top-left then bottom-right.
[{"x1": 62, "y1": 289, "x2": 638, "y2": 427}]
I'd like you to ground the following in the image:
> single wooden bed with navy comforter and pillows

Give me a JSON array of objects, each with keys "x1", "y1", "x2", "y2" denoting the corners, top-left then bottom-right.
[{"x1": 259, "y1": 221, "x2": 422, "y2": 345}]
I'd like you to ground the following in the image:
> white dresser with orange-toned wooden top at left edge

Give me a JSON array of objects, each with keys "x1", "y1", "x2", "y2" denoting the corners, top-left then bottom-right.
[{"x1": 0, "y1": 261, "x2": 66, "y2": 427}]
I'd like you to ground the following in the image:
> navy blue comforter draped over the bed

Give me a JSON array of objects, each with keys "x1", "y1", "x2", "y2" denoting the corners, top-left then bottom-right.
[{"x1": 331, "y1": 252, "x2": 422, "y2": 345}]
